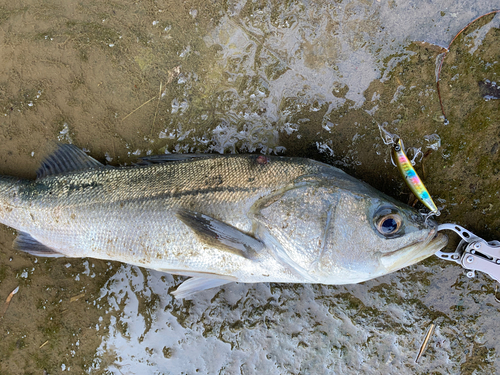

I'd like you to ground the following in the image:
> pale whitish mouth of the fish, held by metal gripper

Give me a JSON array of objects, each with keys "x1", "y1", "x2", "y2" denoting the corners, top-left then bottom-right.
[{"x1": 380, "y1": 226, "x2": 448, "y2": 272}]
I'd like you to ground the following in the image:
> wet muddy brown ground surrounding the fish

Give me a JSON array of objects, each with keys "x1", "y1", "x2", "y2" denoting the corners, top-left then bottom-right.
[{"x1": 0, "y1": 0, "x2": 500, "y2": 375}]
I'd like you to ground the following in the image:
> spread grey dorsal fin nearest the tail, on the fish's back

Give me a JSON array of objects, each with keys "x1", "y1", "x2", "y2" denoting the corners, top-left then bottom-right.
[{"x1": 36, "y1": 144, "x2": 104, "y2": 178}]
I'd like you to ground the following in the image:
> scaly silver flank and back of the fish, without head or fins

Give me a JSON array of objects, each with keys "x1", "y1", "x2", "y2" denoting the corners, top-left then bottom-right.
[{"x1": 1, "y1": 157, "x2": 316, "y2": 282}]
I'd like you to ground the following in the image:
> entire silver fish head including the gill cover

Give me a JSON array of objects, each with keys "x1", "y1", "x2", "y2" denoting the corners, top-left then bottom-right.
[{"x1": 254, "y1": 166, "x2": 447, "y2": 284}]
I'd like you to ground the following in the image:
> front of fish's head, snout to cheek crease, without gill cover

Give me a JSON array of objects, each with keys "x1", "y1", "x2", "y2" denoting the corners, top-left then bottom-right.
[{"x1": 313, "y1": 177, "x2": 448, "y2": 284}]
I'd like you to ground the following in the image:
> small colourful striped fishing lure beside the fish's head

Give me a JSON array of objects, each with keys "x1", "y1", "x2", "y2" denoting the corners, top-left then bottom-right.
[{"x1": 392, "y1": 138, "x2": 440, "y2": 216}]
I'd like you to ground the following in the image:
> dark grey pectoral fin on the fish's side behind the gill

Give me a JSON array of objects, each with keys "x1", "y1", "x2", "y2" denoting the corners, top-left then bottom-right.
[{"x1": 177, "y1": 210, "x2": 264, "y2": 259}]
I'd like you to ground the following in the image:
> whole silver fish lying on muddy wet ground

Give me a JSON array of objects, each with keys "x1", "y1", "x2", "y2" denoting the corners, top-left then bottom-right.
[{"x1": 0, "y1": 144, "x2": 447, "y2": 298}]
